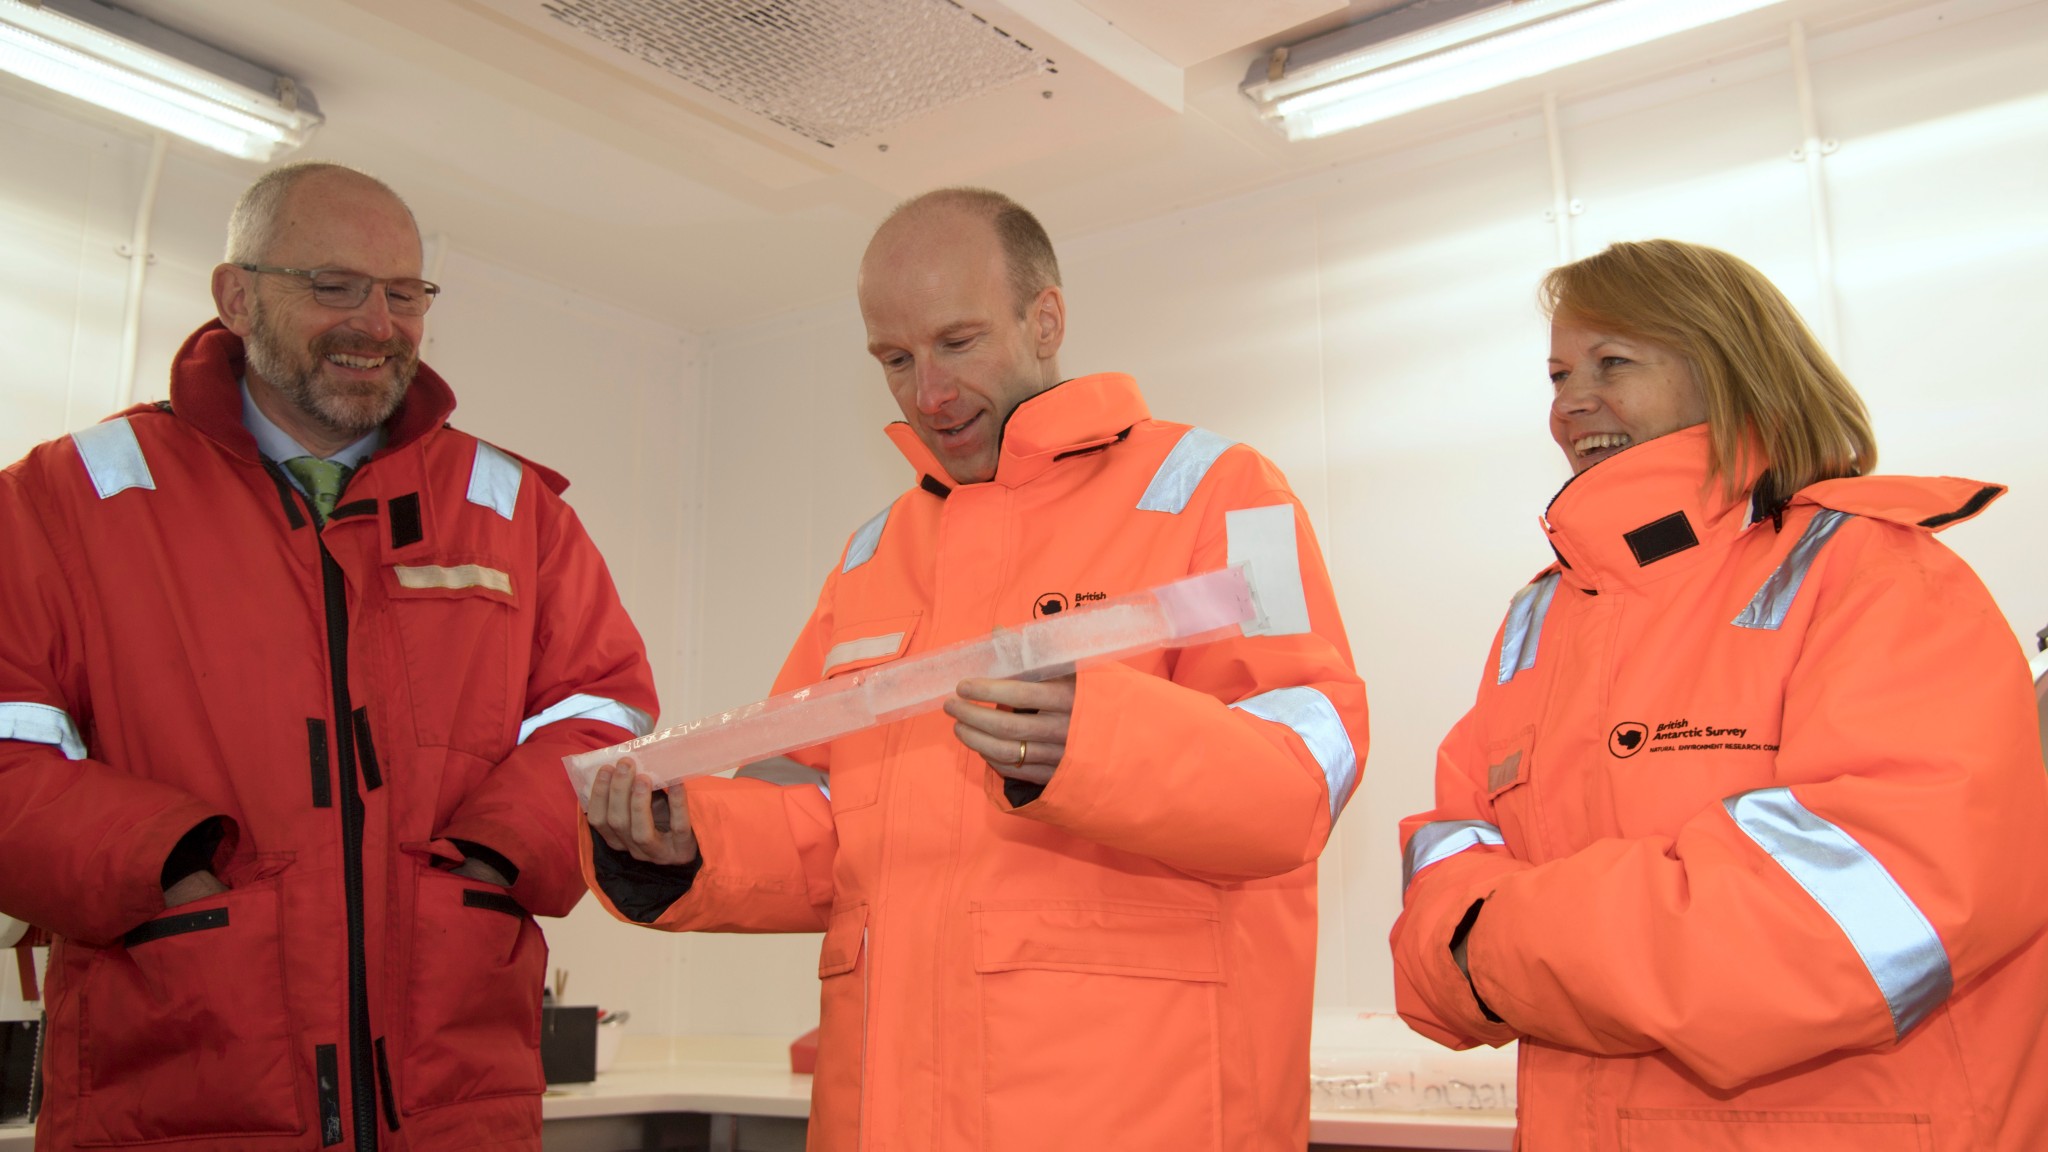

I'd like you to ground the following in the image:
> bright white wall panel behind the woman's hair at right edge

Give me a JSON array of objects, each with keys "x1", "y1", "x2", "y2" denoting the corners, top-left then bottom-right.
[{"x1": 1815, "y1": 4, "x2": 2048, "y2": 637}]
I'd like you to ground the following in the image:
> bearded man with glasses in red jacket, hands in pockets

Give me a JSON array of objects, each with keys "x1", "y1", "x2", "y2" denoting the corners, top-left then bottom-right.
[{"x1": 0, "y1": 164, "x2": 655, "y2": 1152}]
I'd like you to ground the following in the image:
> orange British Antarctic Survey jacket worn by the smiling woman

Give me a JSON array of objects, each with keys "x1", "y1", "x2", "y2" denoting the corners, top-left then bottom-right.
[{"x1": 1393, "y1": 426, "x2": 2048, "y2": 1152}]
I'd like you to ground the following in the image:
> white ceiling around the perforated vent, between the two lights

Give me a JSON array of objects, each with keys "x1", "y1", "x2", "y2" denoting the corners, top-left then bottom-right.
[{"x1": 32, "y1": 0, "x2": 1915, "y2": 332}]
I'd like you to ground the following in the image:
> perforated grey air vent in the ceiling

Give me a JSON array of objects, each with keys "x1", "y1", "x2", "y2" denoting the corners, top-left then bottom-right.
[{"x1": 541, "y1": 0, "x2": 1057, "y2": 148}]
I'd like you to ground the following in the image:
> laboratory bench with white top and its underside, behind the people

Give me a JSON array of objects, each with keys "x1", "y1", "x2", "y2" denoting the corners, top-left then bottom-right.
[{"x1": 0, "y1": 1035, "x2": 1513, "y2": 1152}]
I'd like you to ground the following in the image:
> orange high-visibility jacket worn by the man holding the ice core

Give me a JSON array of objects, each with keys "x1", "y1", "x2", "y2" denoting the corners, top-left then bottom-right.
[{"x1": 586, "y1": 375, "x2": 1366, "y2": 1152}]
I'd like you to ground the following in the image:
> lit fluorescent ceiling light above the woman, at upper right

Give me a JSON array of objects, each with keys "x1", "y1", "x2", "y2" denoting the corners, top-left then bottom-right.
[{"x1": 1243, "y1": 0, "x2": 1784, "y2": 139}]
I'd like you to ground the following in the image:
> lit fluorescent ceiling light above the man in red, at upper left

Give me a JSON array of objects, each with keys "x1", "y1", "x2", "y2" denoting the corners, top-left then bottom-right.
[{"x1": 0, "y1": 0, "x2": 322, "y2": 162}]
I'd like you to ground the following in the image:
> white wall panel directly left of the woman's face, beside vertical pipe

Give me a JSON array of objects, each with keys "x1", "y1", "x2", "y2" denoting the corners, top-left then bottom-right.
[{"x1": 1317, "y1": 129, "x2": 1554, "y2": 1004}]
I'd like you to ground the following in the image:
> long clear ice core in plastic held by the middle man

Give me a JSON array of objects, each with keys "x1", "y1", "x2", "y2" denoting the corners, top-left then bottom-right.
[{"x1": 561, "y1": 564, "x2": 1264, "y2": 801}]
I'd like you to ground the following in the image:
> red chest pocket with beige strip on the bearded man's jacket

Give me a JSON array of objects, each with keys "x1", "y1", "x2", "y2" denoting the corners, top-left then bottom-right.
[{"x1": 381, "y1": 556, "x2": 526, "y2": 760}]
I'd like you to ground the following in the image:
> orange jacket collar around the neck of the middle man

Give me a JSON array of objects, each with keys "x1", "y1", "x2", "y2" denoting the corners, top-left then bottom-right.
[{"x1": 885, "y1": 373, "x2": 1151, "y2": 492}]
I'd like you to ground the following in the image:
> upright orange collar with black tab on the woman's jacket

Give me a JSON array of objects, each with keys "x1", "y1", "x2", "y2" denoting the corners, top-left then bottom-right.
[{"x1": 1542, "y1": 424, "x2": 1755, "y2": 590}]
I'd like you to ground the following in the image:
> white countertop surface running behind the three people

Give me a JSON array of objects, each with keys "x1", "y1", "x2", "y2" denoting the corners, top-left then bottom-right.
[{"x1": 0, "y1": 1035, "x2": 1516, "y2": 1152}]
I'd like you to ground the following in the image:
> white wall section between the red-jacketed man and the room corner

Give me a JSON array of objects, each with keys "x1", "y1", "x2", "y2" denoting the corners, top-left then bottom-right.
[{"x1": 426, "y1": 251, "x2": 702, "y2": 1035}]
